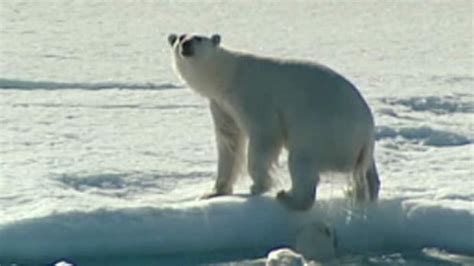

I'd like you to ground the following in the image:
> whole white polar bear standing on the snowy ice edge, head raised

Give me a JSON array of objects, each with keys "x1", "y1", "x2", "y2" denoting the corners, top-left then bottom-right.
[{"x1": 168, "y1": 34, "x2": 380, "y2": 210}]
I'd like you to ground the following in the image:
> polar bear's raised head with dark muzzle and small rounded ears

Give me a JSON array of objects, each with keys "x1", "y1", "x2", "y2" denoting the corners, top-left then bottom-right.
[{"x1": 168, "y1": 34, "x2": 221, "y2": 60}]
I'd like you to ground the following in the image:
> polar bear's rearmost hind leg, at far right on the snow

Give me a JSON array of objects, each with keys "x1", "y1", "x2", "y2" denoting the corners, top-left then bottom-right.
[{"x1": 351, "y1": 138, "x2": 380, "y2": 201}]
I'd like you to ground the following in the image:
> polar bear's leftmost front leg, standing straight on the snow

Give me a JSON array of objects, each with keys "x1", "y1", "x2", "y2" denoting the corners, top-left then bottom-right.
[{"x1": 202, "y1": 101, "x2": 245, "y2": 198}]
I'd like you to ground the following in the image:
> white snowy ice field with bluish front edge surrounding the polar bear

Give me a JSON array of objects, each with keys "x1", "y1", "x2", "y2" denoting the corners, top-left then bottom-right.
[{"x1": 0, "y1": 0, "x2": 474, "y2": 266}]
